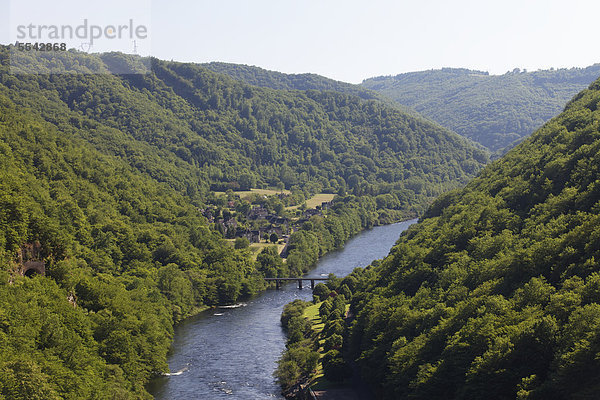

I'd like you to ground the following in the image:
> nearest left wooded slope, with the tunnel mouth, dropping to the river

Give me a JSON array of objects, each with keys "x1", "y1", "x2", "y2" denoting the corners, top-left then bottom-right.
[{"x1": 0, "y1": 86, "x2": 261, "y2": 399}]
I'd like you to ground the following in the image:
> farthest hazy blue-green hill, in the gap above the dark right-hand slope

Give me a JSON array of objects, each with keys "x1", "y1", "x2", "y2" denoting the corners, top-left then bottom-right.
[{"x1": 362, "y1": 64, "x2": 600, "y2": 151}]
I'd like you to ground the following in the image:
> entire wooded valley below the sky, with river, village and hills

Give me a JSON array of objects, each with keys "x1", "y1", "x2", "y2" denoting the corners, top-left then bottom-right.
[{"x1": 0, "y1": 28, "x2": 600, "y2": 400}]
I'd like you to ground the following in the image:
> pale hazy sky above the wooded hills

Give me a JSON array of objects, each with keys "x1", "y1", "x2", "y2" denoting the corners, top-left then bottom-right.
[{"x1": 0, "y1": 0, "x2": 600, "y2": 83}]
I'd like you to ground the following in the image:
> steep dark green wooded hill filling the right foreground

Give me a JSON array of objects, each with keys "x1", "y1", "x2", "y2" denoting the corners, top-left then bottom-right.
[{"x1": 347, "y1": 76, "x2": 600, "y2": 399}]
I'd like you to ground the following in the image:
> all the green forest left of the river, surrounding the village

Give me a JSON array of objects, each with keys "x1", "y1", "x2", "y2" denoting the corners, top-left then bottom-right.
[{"x1": 0, "y1": 47, "x2": 487, "y2": 399}]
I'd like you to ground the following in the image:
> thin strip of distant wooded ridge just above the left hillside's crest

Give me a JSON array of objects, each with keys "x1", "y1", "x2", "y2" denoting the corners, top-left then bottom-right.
[{"x1": 201, "y1": 62, "x2": 382, "y2": 100}]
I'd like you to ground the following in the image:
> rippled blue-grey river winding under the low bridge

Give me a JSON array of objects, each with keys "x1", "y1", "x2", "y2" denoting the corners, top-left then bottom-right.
[{"x1": 148, "y1": 220, "x2": 416, "y2": 400}]
